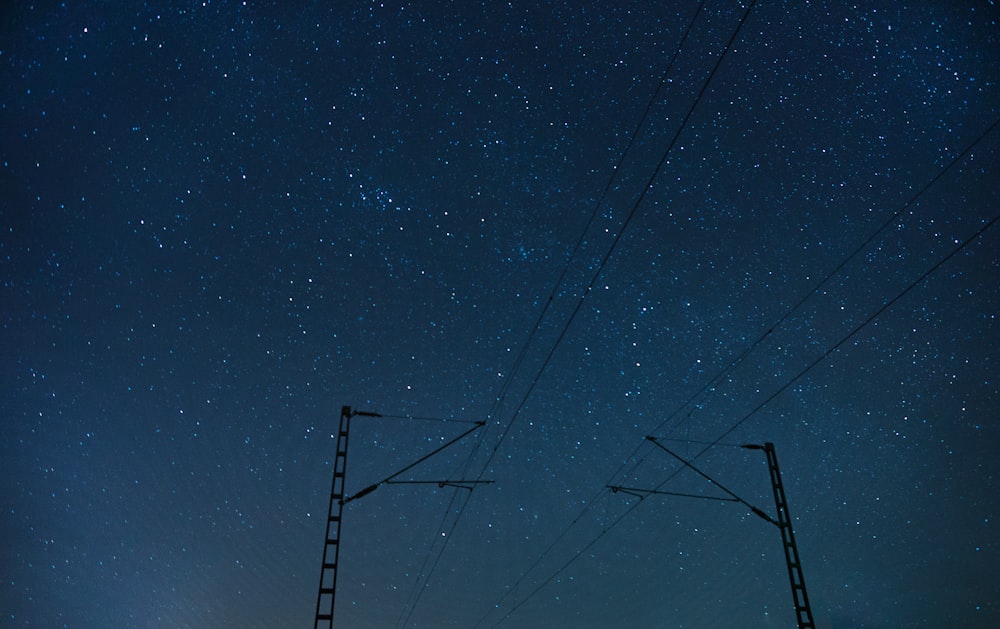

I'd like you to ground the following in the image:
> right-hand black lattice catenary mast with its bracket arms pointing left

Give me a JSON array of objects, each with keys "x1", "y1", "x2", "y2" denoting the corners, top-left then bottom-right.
[{"x1": 608, "y1": 437, "x2": 816, "y2": 629}]
